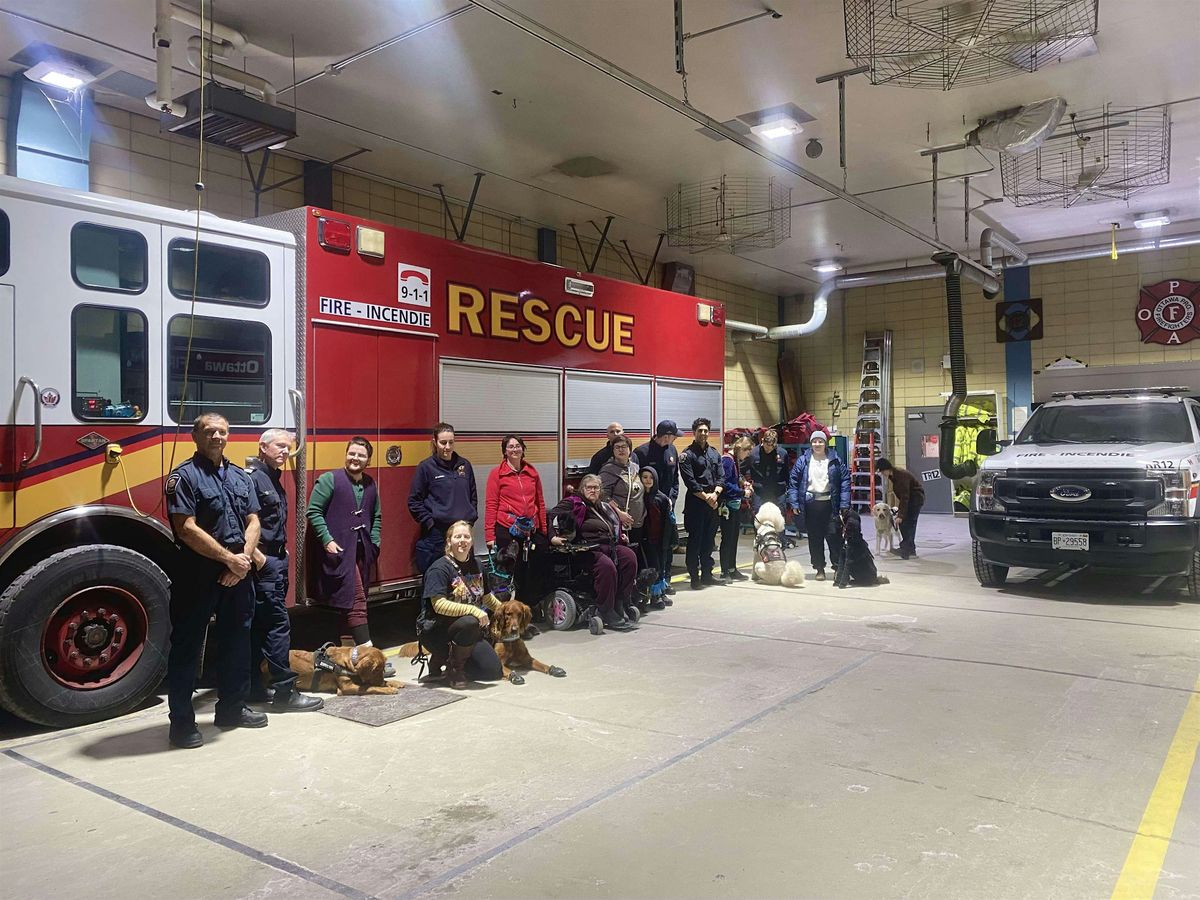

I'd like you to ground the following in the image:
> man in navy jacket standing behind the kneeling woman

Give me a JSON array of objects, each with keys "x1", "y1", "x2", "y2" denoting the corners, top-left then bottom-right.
[{"x1": 408, "y1": 422, "x2": 479, "y2": 572}]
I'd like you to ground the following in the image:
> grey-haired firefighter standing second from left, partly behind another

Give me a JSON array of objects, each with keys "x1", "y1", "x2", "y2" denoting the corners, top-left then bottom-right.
[{"x1": 246, "y1": 428, "x2": 325, "y2": 713}]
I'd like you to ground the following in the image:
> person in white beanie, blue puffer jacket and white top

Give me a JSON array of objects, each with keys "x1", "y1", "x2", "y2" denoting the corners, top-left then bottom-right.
[{"x1": 787, "y1": 431, "x2": 850, "y2": 581}]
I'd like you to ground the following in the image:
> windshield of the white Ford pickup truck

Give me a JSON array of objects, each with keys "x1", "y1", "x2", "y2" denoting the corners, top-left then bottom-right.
[{"x1": 1016, "y1": 403, "x2": 1192, "y2": 444}]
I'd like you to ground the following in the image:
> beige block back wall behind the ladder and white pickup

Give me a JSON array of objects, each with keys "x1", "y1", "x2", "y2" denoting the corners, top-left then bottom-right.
[{"x1": 796, "y1": 247, "x2": 1200, "y2": 460}]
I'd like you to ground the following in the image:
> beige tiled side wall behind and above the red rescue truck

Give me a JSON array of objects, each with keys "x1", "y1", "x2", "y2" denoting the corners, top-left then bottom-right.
[{"x1": 0, "y1": 85, "x2": 779, "y2": 434}]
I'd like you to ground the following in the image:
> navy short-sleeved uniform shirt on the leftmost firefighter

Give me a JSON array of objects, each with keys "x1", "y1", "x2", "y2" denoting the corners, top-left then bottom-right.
[{"x1": 166, "y1": 452, "x2": 260, "y2": 554}]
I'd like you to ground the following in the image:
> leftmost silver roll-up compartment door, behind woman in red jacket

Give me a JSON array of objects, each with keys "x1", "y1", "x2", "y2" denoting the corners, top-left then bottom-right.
[{"x1": 442, "y1": 360, "x2": 563, "y2": 546}]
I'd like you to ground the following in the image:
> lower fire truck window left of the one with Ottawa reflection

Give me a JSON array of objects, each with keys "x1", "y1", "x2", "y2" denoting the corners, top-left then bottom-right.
[{"x1": 71, "y1": 306, "x2": 150, "y2": 420}]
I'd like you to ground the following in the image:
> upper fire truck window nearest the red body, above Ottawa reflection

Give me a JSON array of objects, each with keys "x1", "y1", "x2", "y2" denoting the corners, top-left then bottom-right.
[{"x1": 167, "y1": 238, "x2": 271, "y2": 306}]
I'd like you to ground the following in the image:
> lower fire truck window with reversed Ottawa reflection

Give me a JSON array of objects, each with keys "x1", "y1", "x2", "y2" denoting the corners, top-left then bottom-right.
[{"x1": 167, "y1": 316, "x2": 271, "y2": 425}]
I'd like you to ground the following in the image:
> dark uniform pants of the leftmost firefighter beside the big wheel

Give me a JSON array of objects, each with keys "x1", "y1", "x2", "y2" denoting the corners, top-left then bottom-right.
[{"x1": 167, "y1": 564, "x2": 254, "y2": 728}]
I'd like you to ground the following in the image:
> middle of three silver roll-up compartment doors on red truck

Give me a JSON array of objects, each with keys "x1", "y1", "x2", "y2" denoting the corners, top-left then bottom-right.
[{"x1": 566, "y1": 372, "x2": 654, "y2": 468}]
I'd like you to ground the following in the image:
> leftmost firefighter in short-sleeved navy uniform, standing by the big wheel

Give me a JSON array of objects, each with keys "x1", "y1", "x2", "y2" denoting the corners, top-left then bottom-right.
[{"x1": 166, "y1": 413, "x2": 266, "y2": 749}]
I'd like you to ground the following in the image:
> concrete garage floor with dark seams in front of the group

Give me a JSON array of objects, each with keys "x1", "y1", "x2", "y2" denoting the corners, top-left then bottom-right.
[{"x1": 0, "y1": 516, "x2": 1200, "y2": 900}]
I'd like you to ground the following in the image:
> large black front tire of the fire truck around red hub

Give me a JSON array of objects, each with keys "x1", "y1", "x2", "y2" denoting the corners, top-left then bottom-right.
[{"x1": 0, "y1": 544, "x2": 170, "y2": 727}]
